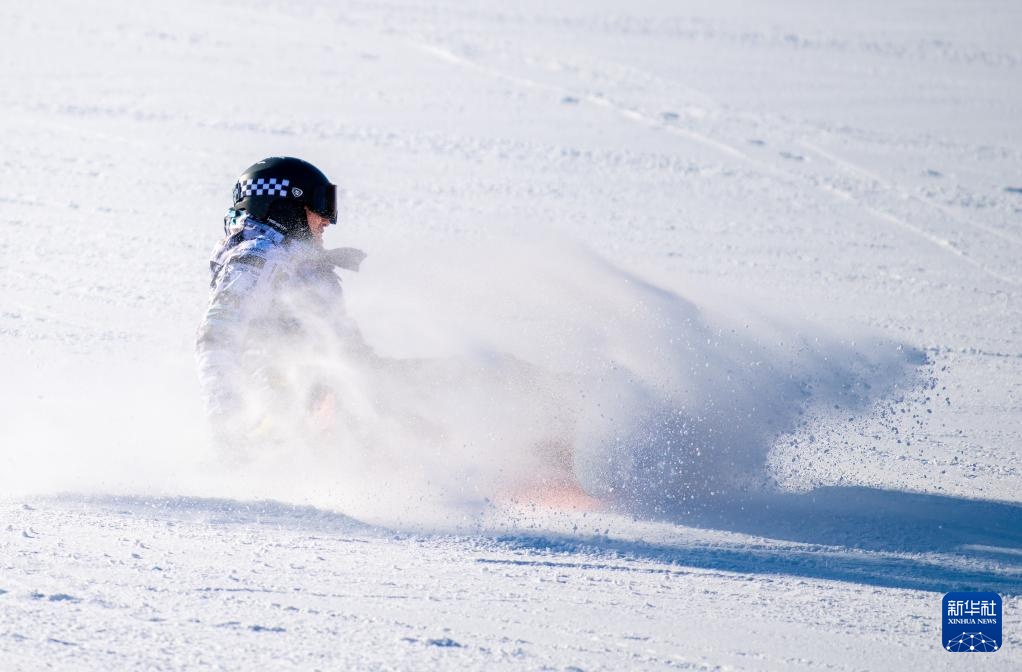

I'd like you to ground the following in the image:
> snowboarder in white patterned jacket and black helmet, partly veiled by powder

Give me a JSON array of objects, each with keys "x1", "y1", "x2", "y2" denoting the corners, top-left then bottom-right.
[{"x1": 196, "y1": 157, "x2": 367, "y2": 446}]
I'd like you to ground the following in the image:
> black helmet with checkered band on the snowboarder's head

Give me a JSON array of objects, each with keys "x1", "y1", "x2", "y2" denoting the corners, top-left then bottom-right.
[{"x1": 234, "y1": 156, "x2": 337, "y2": 233}]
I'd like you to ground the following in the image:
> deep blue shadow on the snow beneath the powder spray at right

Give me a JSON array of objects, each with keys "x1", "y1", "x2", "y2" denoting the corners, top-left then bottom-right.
[{"x1": 501, "y1": 487, "x2": 1022, "y2": 594}]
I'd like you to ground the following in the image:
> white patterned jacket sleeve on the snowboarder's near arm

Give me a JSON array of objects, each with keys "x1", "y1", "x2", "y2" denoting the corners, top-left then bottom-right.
[{"x1": 195, "y1": 251, "x2": 278, "y2": 418}]
